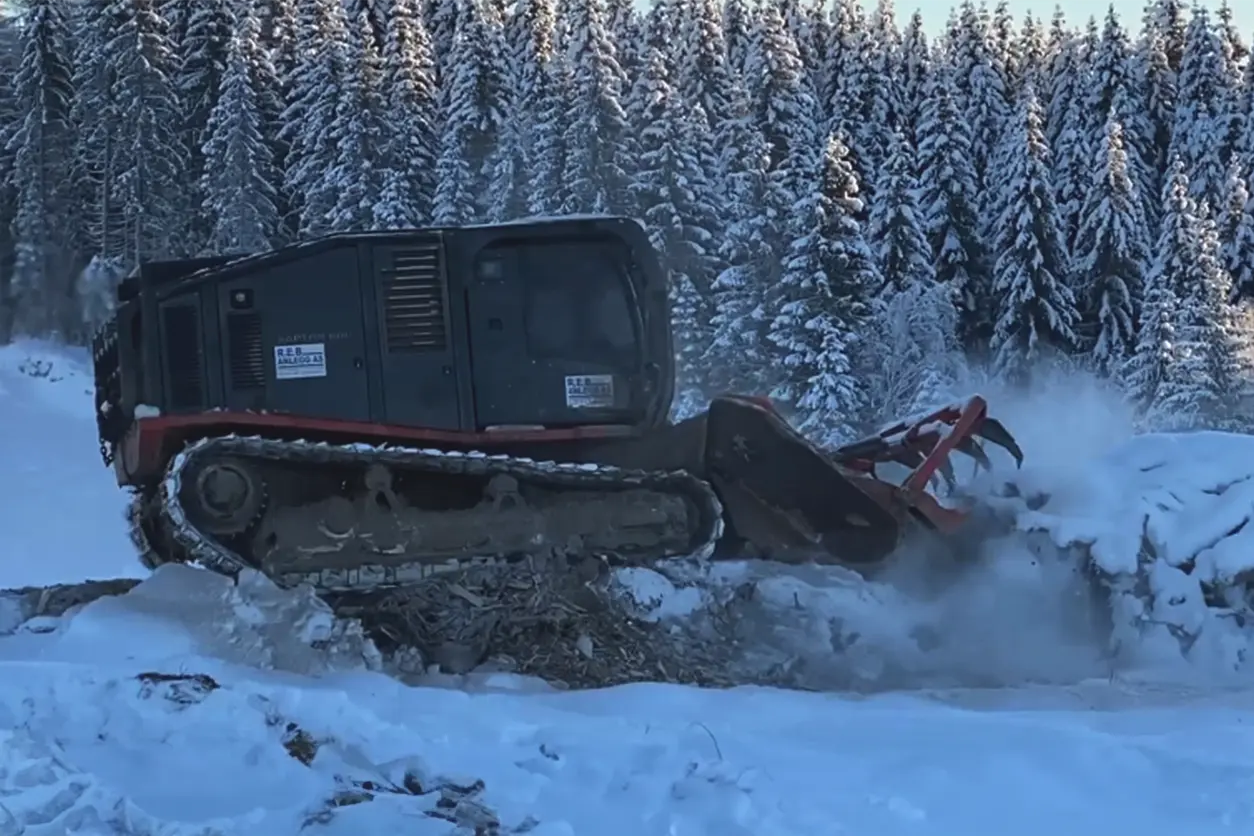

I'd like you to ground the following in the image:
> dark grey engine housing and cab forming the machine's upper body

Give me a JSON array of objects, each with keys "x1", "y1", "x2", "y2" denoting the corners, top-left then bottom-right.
[{"x1": 97, "y1": 217, "x2": 673, "y2": 461}]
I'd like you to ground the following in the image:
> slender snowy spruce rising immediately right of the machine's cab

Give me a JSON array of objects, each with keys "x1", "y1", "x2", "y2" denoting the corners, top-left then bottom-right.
[{"x1": 630, "y1": 46, "x2": 717, "y2": 406}]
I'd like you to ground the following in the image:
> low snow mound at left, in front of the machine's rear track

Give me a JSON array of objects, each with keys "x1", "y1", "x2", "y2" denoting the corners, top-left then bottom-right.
[{"x1": 0, "y1": 564, "x2": 381, "y2": 674}]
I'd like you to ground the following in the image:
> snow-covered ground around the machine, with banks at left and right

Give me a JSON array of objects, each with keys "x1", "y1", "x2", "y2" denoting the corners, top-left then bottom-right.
[{"x1": 0, "y1": 343, "x2": 1254, "y2": 836}]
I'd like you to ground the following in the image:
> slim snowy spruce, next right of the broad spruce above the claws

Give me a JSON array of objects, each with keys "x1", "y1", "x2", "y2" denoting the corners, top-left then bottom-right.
[{"x1": 1072, "y1": 107, "x2": 1149, "y2": 377}]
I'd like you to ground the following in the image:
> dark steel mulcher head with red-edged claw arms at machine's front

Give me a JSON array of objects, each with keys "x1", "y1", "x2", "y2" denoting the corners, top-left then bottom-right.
[{"x1": 705, "y1": 396, "x2": 1023, "y2": 565}]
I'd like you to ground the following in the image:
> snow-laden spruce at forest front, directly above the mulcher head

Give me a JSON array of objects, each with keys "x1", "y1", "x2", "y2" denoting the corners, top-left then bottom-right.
[{"x1": 767, "y1": 137, "x2": 883, "y2": 445}]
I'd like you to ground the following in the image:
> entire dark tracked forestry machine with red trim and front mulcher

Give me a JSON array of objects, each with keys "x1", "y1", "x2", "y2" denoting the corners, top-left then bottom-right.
[{"x1": 93, "y1": 217, "x2": 1022, "y2": 661}]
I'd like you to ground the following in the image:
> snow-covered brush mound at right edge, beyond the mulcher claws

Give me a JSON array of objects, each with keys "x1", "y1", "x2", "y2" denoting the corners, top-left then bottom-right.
[{"x1": 989, "y1": 431, "x2": 1254, "y2": 674}]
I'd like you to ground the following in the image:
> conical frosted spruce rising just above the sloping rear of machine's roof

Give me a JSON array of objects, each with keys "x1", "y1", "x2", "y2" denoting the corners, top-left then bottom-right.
[{"x1": 199, "y1": 6, "x2": 278, "y2": 254}]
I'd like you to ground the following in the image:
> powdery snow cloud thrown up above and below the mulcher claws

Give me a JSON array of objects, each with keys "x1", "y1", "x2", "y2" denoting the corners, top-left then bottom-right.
[{"x1": 717, "y1": 374, "x2": 1134, "y2": 689}]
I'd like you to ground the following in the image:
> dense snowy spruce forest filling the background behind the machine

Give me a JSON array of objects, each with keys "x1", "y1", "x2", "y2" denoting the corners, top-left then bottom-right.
[{"x1": 0, "y1": 0, "x2": 1254, "y2": 441}]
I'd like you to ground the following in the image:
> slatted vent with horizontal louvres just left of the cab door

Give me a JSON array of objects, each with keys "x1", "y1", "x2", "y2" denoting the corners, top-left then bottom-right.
[{"x1": 384, "y1": 243, "x2": 448, "y2": 353}]
